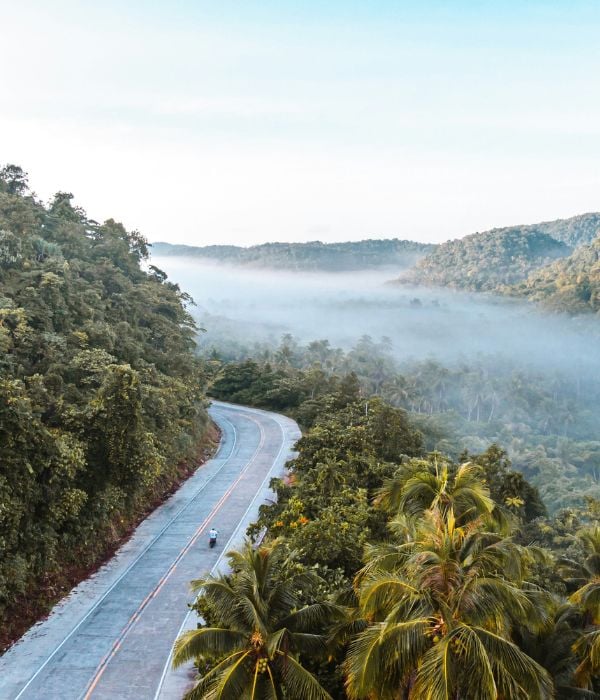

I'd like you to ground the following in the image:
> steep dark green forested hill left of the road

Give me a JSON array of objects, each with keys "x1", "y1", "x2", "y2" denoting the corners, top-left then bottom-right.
[{"x1": 0, "y1": 166, "x2": 207, "y2": 631}]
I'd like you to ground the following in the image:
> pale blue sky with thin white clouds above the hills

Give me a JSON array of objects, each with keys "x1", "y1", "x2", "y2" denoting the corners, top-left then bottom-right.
[{"x1": 0, "y1": 0, "x2": 600, "y2": 245}]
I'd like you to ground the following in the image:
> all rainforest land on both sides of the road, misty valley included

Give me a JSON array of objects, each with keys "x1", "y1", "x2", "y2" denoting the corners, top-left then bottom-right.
[{"x1": 0, "y1": 160, "x2": 600, "y2": 700}]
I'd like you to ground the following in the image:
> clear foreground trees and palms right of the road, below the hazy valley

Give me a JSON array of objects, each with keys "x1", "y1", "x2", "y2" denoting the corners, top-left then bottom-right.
[{"x1": 182, "y1": 373, "x2": 600, "y2": 700}]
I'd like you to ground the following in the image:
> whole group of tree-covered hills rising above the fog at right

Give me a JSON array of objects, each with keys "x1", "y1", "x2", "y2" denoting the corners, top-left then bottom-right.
[{"x1": 398, "y1": 214, "x2": 600, "y2": 314}]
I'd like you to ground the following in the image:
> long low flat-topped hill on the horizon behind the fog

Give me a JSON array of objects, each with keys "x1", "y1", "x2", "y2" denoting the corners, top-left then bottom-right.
[{"x1": 152, "y1": 238, "x2": 434, "y2": 272}]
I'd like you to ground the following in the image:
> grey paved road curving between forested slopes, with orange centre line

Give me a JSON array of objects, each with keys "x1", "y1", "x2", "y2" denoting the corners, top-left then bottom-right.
[{"x1": 0, "y1": 402, "x2": 300, "y2": 700}]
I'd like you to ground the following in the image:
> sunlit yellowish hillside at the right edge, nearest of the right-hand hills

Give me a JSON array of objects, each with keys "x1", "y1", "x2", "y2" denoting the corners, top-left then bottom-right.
[{"x1": 509, "y1": 237, "x2": 600, "y2": 313}]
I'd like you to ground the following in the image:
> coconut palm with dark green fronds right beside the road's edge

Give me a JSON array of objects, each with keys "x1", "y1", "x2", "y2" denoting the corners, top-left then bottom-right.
[{"x1": 173, "y1": 542, "x2": 339, "y2": 700}]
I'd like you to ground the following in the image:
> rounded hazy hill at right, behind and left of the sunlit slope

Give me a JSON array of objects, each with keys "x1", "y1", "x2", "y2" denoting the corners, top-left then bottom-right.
[{"x1": 397, "y1": 222, "x2": 571, "y2": 291}]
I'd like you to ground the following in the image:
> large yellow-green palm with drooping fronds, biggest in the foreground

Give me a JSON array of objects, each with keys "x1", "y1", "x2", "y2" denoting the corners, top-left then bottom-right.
[{"x1": 345, "y1": 506, "x2": 554, "y2": 700}]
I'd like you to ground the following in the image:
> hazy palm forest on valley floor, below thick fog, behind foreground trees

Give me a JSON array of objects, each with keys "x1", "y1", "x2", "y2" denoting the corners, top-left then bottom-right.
[{"x1": 207, "y1": 336, "x2": 600, "y2": 511}]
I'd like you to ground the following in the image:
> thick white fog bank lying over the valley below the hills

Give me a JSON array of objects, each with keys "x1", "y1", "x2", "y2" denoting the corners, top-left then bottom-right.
[{"x1": 152, "y1": 257, "x2": 600, "y2": 376}]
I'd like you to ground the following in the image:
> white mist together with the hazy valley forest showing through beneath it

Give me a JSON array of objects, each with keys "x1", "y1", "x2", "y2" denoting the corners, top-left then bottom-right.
[{"x1": 152, "y1": 257, "x2": 600, "y2": 511}]
